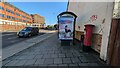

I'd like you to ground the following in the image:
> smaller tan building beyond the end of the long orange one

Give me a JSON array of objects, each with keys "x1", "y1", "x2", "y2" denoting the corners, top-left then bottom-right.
[{"x1": 31, "y1": 14, "x2": 45, "y2": 28}]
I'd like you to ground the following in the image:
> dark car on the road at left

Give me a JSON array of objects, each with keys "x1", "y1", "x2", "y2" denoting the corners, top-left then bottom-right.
[{"x1": 17, "y1": 27, "x2": 39, "y2": 37}]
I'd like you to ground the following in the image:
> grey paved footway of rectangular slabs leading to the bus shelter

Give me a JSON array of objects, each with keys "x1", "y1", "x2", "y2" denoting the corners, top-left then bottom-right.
[{"x1": 2, "y1": 33, "x2": 107, "y2": 68}]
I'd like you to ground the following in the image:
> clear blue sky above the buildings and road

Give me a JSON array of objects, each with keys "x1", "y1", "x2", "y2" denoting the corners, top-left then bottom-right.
[{"x1": 10, "y1": 2, "x2": 67, "y2": 25}]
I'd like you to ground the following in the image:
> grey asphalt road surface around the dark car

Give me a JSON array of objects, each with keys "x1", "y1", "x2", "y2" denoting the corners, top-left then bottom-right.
[{"x1": 2, "y1": 32, "x2": 45, "y2": 48}]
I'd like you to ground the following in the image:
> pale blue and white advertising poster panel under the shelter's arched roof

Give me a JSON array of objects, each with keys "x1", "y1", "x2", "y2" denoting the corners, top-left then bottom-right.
[{"x1": 58, "y1": 16, "x2": 74, "y2": 40}]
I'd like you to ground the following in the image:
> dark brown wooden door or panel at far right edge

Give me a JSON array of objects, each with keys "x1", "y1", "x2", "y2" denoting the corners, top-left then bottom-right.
[{"x1": 108, "y1": 19, "x2": 120, "y2": 66}]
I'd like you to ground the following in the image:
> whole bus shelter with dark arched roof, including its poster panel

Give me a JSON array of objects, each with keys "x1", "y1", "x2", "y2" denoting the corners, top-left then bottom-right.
[{"x1": 57, "y1": 12, "x2": 77, "y2": 45}]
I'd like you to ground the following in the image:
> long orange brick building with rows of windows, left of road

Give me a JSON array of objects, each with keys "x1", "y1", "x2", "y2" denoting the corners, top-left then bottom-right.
[{"x1": 0, "y1": 2, "x2": 32, "y2": 31}]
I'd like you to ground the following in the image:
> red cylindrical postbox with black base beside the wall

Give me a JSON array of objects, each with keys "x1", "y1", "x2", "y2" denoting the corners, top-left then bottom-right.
[{"x1": 83, "y1": 24, "x2": 94, "y2": 52}]
